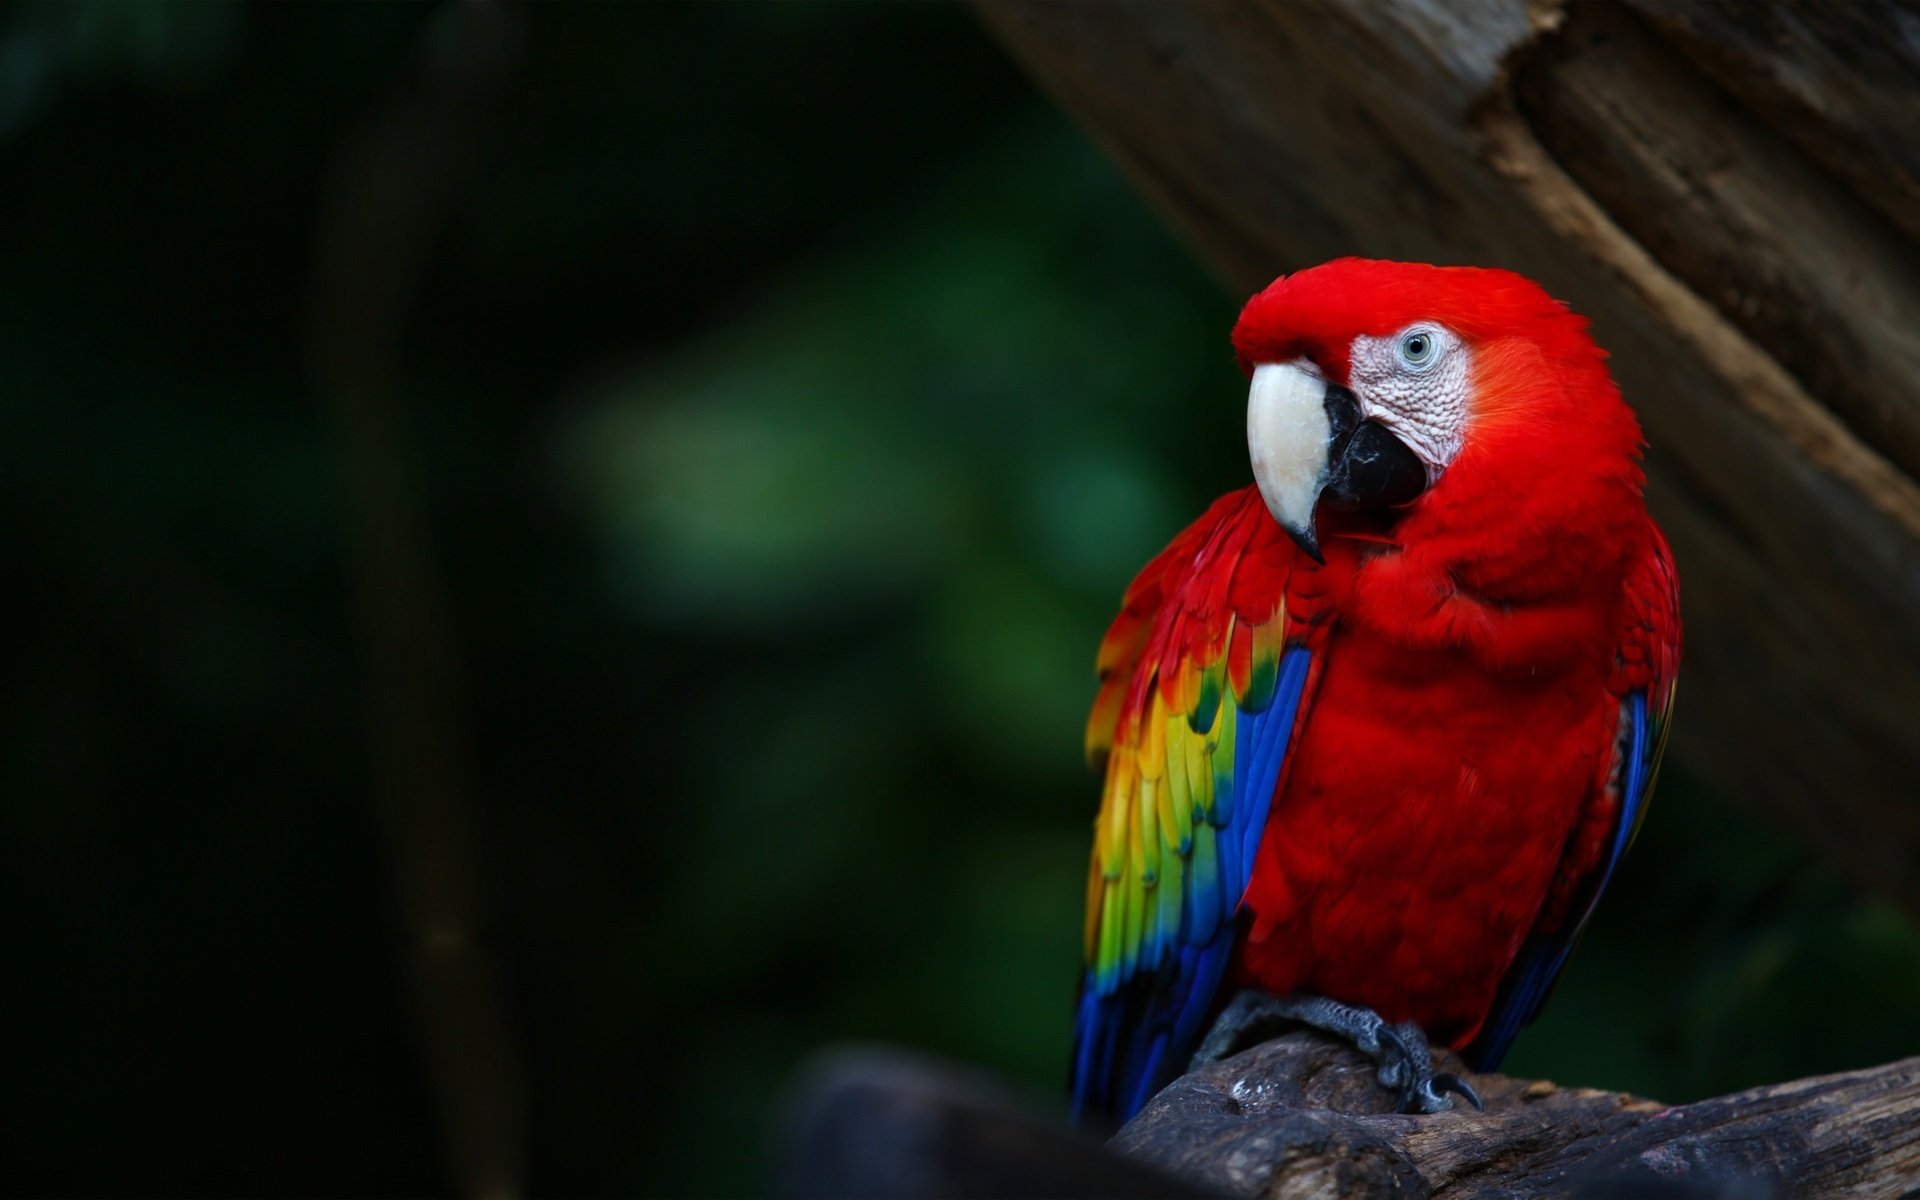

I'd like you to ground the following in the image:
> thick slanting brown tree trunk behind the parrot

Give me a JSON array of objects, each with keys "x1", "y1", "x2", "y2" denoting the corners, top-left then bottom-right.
[{"x1": 981, "y1": 0, "x2": 1920, "y2": 912}]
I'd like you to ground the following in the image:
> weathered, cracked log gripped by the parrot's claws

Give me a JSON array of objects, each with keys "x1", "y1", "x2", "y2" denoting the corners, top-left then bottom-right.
[{"x1": 1112, "y1": 1033, "x2": 1920, "y2": 1200}]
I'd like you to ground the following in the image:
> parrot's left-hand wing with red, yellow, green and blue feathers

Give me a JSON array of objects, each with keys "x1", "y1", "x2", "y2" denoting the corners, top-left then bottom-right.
[{"x1": 1071, "y1": 488, "x2": 1309, "y2": 1119}]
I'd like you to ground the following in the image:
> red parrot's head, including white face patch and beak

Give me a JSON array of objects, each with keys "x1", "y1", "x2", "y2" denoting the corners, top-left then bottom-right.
[{"x1": 1233, "y1": 259, "x2": 1640, "y2": 559}]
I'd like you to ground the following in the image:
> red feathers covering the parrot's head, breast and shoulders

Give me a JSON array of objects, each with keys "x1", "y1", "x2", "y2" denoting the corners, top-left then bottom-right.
[{"x1": 1077, "y1": 259, "x2": 1680, "y2": 1108}]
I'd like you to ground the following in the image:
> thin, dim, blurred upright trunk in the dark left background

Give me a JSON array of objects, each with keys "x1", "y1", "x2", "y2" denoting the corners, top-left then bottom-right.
[{"x1": 307, "y1": 4, "x2": 526, "y2": 1200}]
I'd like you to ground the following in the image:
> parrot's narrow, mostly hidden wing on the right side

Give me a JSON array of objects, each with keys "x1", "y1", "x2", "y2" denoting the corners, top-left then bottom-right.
[{"x1": 1465, "y1": 522, "x2": 1680, "y2": 1071}]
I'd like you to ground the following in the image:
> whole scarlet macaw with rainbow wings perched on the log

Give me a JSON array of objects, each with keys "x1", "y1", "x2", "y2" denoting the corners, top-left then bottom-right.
[{"x1": 1069, "y1": 257, "x2": 1680, "y2": 1123}]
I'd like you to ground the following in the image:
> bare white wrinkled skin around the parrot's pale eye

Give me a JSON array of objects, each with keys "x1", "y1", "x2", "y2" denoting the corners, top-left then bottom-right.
[{"x1": 1348, "y1": 321, "x2": 1473, "y2": 482}]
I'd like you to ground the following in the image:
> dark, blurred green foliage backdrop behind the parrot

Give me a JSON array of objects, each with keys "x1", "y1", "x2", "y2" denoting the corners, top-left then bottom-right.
[{"x1": 0, "y1": 0, "x2": 1920, "y2": 1194}]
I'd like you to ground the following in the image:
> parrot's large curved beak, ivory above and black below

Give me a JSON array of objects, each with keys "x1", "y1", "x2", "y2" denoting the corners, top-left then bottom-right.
[{"x1": 1246, "y1": 361, "x2": 1427, "y2": 563}]
